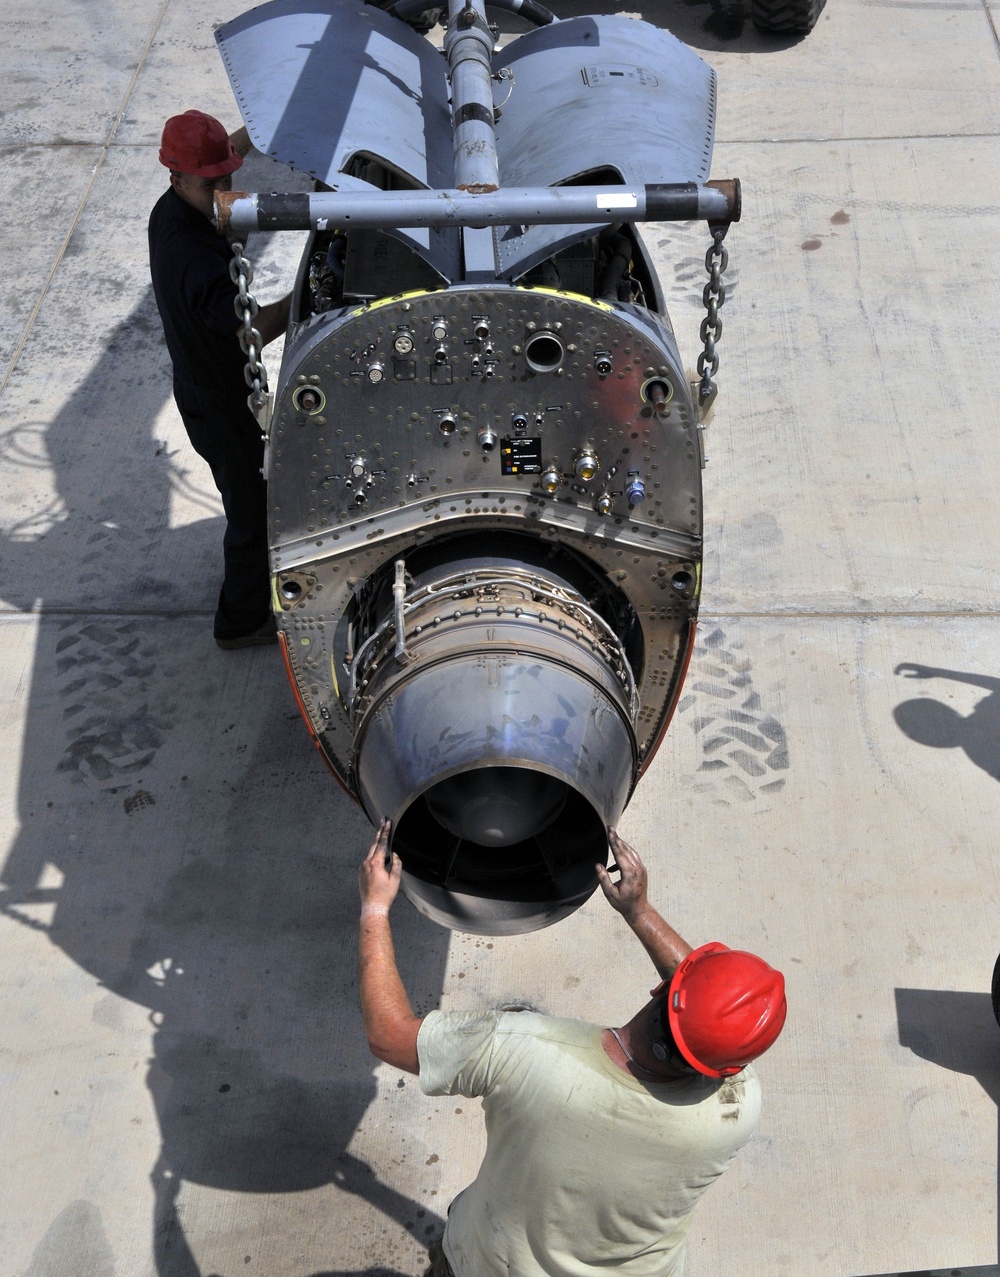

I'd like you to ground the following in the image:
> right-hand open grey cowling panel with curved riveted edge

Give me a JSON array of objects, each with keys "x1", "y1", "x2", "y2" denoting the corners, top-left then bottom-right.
[{"x1": 493, "y1": 15, "x2": 715, "y2": 278}]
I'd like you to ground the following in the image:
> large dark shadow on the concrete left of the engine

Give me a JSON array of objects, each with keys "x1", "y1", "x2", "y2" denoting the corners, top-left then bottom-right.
[{"x1": 0, "y1": 251, "x2": 448, "y2": 1277}]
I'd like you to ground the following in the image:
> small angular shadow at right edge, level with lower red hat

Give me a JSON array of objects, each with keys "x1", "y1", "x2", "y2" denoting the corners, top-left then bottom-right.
[{"x1": 893, "y1": 988, "x2": 1000, "y2": 1277}]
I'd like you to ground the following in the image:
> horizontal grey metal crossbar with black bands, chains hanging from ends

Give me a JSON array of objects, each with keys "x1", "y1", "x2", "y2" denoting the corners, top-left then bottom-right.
[{"x1": 216, "y1": 178, "x2": 739, "y2": 235}]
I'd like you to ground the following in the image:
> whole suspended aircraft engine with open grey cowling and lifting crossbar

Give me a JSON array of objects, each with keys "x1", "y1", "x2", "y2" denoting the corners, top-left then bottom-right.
[{"x1": 217, "y1": 0, "x2": 739, "y2": 933}]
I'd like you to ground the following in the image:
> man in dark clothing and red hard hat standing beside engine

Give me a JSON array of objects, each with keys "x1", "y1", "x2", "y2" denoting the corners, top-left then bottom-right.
[{"x1": 149, "y1": 111, "x2": 290, "y2": 647}]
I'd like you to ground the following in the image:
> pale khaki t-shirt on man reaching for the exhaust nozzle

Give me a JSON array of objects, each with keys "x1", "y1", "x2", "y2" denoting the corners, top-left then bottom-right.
[{"x1": 416, "y1": 1011, "x2": 760, "y2": 1277}]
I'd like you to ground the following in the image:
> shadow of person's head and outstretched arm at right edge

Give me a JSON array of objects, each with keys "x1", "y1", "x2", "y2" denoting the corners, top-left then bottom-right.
[{"x1": 893, "y1": 661, "x2": 1000, "y2": 780}]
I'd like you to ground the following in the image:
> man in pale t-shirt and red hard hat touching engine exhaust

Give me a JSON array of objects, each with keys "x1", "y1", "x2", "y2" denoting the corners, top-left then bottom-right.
[{"x1": 359, "y1": 821, "x2": 785, "y2": 1277}]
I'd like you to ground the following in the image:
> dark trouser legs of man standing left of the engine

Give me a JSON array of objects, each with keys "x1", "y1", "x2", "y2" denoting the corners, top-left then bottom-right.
[{"x1": 174, "y1": 387, "x2": 271, "y2": 639}]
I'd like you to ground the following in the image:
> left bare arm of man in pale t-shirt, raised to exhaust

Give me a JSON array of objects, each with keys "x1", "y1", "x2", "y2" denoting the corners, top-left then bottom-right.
[{"x1": 358, "y1": 820, "x2": 423, "y2": 1073}]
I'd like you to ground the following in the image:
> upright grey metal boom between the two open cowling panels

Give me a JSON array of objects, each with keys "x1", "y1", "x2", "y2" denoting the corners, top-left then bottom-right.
[{"x1": 444, "y1": 0, "x2": 499, "y2": 194}]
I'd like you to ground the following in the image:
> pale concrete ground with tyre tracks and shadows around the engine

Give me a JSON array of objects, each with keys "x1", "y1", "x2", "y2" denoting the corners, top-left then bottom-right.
[{"x1": 0, "y1": 0, "x2": 1000, "y2": 1277}]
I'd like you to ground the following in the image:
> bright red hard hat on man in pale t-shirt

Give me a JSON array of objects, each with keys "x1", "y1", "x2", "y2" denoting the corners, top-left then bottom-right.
[{"x1": 667, "y1": 942, "x2": 785, "y2": 1078}]
